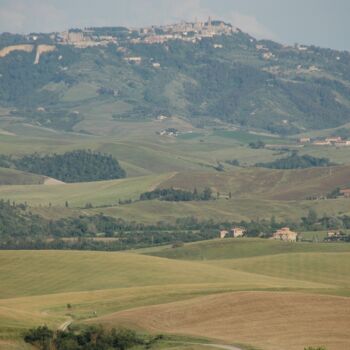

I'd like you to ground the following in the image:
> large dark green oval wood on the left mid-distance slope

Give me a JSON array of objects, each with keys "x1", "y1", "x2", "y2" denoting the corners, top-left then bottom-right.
[{"x1": 11, "y1": 150, "x2": 126, "y2": 183}]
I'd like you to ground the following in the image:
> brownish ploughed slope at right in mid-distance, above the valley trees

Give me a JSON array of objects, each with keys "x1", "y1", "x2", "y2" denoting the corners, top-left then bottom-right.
[{"x1": 161, "y1": 166, "x2": 350, "y2": 200}]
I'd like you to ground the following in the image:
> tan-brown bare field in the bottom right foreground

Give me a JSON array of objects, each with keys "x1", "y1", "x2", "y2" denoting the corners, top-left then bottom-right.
[{"x1": 96, "y1": 292, "x2": 350, "y2": 350}]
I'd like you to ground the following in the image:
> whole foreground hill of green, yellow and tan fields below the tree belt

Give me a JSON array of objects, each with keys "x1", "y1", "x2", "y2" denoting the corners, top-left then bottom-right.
[{"x1": 0, "y1": 239, "x2": 349, "y2": 350}]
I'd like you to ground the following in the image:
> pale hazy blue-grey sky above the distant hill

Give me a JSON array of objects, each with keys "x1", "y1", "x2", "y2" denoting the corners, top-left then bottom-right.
[{"x1": 0, "y1": 0, "x2": 350, "y2": 51}]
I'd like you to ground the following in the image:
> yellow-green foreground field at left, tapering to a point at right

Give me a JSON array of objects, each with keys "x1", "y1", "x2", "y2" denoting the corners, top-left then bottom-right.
[{"x1": 0, "y1": 251, "x2": 326, "y2": 298}]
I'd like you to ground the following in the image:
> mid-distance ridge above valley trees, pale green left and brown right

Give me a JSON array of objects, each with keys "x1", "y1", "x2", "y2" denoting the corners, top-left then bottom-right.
[{"x1": 0, "y1": 166, "x2": 350, "y2": 210}]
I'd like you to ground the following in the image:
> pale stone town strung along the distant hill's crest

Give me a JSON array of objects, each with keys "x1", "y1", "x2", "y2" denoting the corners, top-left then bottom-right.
[{"x1": 0, "y1": 17, "x2": 240, "y2": 64}]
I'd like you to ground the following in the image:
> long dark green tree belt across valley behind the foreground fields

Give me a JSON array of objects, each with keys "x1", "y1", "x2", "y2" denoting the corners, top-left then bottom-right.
[{"x1": 0, "y1": 201, "x2": 350, "y2": 251}]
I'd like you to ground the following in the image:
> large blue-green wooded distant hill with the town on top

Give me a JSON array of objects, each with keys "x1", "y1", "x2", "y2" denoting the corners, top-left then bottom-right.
[{"x1": 0, "y1": 21, "x2": 350, "y2": 134}]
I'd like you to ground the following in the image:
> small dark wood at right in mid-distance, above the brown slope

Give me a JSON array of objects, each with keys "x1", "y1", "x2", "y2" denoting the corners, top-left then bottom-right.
[{"x1": 256, "y1": 152, "x2": 335, "y2": 170}]
